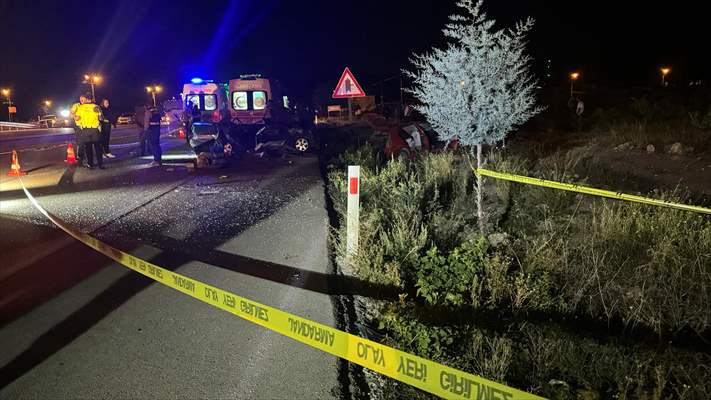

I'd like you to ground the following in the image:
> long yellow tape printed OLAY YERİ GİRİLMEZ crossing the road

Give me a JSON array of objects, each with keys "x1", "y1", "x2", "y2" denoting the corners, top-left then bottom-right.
[{"x1": 20, "y1": 179, "x2": 542, "y2": 400}]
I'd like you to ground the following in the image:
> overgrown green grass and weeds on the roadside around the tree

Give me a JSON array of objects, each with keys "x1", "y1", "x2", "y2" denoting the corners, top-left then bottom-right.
[{"x1": 329, "y1": 140, "x2": 711, "y2": 399}]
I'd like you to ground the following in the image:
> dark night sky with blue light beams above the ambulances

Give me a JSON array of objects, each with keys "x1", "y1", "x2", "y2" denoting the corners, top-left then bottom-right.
[{"x1": 0, "y1": 0, "x2": 711, "y2": 119}]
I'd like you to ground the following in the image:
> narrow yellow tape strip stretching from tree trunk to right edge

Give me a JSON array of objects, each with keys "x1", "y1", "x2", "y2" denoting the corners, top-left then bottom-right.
[{"x1": 474, "y1": 168, "x2": 711, "y2": 214}]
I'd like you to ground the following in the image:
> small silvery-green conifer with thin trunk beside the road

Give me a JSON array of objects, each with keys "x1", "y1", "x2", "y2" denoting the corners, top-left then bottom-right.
[{"x1": 405, "y1": 0, "x2": 543, "y2": 231}]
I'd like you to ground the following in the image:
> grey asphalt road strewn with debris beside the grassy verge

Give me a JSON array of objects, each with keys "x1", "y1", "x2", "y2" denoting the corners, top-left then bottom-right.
[{"x1": 0, "y1": 129, "x2": 351, "y2": 399}]
